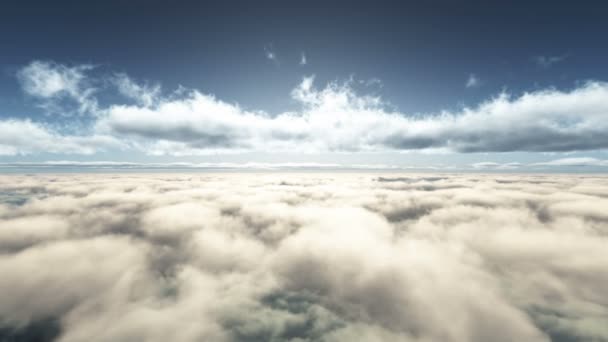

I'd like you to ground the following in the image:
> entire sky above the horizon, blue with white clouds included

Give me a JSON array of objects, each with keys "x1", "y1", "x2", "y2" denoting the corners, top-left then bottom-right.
[{"x1": 0, "y1": 1, "x2": 608, "y2": 172}]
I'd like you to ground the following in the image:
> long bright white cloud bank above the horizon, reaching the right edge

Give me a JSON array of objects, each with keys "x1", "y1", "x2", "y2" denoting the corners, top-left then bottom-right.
[{"x1": 98, "y1": 77, "x2": 608, "y2": 154}]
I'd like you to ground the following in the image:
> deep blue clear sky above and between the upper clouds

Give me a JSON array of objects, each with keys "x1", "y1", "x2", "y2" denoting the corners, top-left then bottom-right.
[{"x1": 0, "y1": 1, "x2": 608, "y2": 171}]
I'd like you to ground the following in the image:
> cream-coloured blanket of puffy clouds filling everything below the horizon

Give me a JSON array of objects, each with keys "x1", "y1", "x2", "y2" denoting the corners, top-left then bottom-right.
[{"x1": 0, "y1": 173, "x2": 608, "y2": 342}]
